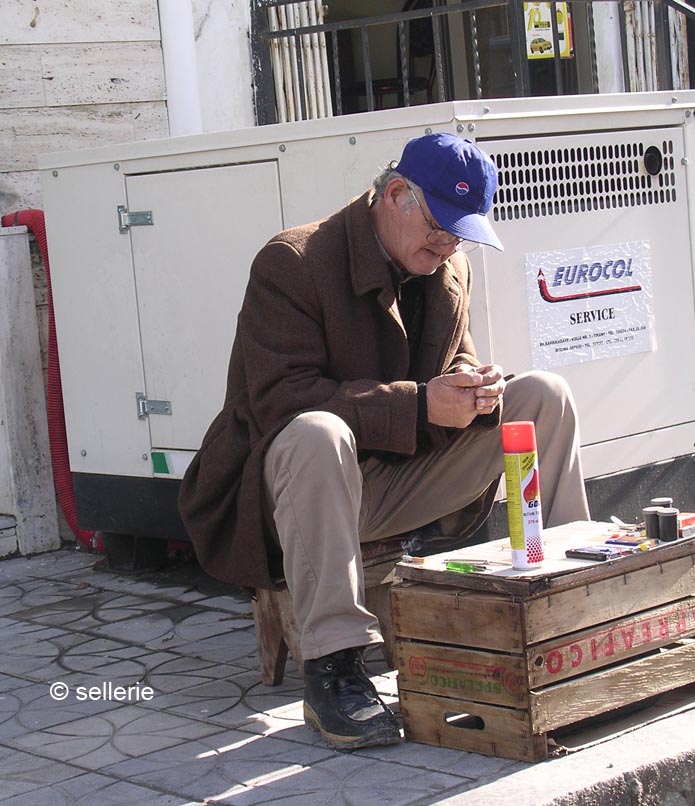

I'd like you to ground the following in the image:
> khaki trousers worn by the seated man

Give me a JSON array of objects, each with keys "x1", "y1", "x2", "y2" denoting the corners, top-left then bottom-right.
[{"x1": 265, "y1": 372, "x2": 589, "y2": 659}]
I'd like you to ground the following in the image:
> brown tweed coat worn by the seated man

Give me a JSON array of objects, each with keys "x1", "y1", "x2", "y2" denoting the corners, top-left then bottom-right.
[{"x1": 179, "y1": 191, "x2": 499, "y2": 587}]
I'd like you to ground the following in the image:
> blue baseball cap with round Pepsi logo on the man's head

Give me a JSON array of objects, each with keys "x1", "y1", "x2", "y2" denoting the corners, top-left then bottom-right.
[{"x1": 396, "y1": 132, "x2": 504, "y2": 251}]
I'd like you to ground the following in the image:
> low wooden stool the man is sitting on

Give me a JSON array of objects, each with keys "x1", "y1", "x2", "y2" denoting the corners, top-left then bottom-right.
[{"x1": 253, "y1": 538, "x2": 403, "y2": 686}]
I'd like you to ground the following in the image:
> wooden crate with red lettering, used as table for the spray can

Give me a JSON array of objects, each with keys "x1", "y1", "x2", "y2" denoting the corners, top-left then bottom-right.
[{"x1": 391, "y1": 523, "x2": 695, "y2": 761}]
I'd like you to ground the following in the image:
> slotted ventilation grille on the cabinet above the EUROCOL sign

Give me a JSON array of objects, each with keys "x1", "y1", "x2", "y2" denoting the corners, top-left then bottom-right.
[{"x1": 492, "y1": 140, "x2": 676, "y2": 221}]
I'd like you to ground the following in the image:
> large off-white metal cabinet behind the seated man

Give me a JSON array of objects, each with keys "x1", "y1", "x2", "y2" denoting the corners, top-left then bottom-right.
[{"x1": 40, "y1": 91, "x2": 695, "y2": 544}]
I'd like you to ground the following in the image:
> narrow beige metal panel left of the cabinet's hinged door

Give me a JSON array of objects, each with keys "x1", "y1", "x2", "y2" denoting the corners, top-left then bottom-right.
[{"x1": 41, "y1": 163, "x2": 151, "y2": 476}]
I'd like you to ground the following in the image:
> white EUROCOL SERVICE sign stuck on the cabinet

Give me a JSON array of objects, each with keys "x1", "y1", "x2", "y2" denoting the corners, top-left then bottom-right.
[{"x1": 524, "y1": 241, "x2": 656, "y2": 369}]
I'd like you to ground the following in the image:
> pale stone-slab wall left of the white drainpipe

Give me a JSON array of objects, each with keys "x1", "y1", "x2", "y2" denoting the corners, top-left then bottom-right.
[{"x1": 0, "y1": 0, "x2": 167, "y2": 213}]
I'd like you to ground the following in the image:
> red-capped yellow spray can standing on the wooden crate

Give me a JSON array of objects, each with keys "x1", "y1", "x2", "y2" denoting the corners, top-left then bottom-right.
[{"x1": 502, "y1": 421, "x2": 544, "y2": 570}]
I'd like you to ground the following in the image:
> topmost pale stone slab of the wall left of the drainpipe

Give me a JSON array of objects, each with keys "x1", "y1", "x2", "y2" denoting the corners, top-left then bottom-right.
[{"x1": 0, "y1": 0, "x2": 159, "y2": 45}]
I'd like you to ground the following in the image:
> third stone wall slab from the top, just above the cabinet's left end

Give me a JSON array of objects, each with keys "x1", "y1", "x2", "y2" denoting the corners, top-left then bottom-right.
[{"x1": 0, "y1": 101, "x2": 169, "y2": 172}]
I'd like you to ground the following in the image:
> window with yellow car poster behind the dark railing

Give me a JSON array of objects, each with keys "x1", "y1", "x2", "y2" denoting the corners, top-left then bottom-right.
[{"x1": 252, "y1": 0, "x2": 695, "y2": 123}]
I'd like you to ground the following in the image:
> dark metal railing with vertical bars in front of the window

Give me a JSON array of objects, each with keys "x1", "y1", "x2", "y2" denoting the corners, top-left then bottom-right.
[{"x1": 252, "y1": 0, "x2": 695, "y2": 123}]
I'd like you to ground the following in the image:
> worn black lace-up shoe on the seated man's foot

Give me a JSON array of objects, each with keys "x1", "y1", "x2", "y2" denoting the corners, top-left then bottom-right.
[{"x1": 304, "y1": 648, "x2": 401, "y2": 750}]
